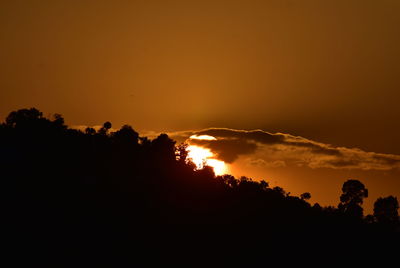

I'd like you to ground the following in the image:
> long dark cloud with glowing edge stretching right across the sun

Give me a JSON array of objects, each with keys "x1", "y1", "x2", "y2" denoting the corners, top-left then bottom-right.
[{"x1": 169, "y1": 128, "x2": 400, "y2": 170}]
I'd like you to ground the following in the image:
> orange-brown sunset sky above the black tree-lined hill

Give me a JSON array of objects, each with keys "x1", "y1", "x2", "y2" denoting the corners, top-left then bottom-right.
[{"x1": 0, "y1": 0, "x2": 400, "y2": 212}]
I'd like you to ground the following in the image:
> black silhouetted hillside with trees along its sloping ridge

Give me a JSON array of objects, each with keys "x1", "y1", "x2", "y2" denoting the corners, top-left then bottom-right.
[{"x1": 0, "y1": 108, "x2": 400, "y2": 266}]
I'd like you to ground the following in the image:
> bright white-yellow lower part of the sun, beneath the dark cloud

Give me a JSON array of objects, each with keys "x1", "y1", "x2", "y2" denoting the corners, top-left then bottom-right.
[{"x1": 187, "y1": 145, "x2": 228, "y2": 175}]
